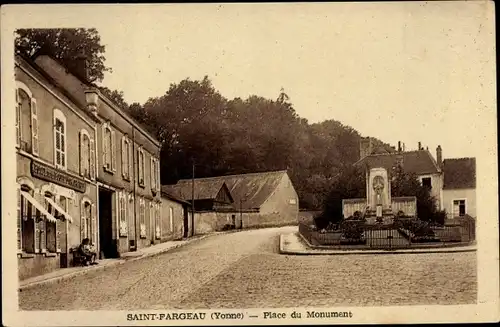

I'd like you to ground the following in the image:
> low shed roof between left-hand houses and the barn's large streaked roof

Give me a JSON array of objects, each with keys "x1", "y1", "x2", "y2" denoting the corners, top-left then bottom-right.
[{"x1": 161, "y1": 178, "x2": 231, "y2": 200}]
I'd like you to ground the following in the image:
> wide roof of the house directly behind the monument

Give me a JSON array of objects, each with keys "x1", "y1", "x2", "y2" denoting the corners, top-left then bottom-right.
[{"x1": 355, "y1": 150, "x2": 439, "y2": 175}]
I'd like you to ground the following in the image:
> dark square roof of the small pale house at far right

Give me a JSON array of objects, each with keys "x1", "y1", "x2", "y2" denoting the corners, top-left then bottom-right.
[{"x1": 443, "y1": 158, "x2": 476, "y2": 189}]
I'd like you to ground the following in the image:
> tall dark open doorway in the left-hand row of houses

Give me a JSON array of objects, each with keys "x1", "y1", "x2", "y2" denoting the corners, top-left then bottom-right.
[{"x1": 99, "y1": 188, "x2": 117, "y2": 259}]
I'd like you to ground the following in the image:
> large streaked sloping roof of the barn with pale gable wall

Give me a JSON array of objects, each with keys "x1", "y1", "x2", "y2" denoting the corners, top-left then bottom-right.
[{"x1": 166, "y1": 170, "x2": 287, "y2": 210}]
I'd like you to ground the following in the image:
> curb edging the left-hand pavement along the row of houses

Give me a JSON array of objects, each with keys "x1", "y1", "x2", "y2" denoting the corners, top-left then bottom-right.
[{"x1": 18, "y1": 233, "x2": 215, "y2": 292}]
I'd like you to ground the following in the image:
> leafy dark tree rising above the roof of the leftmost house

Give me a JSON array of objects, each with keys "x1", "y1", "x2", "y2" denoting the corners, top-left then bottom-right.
[{"x1": 15, "y1": 28, "x2": 111, "y2": 82}]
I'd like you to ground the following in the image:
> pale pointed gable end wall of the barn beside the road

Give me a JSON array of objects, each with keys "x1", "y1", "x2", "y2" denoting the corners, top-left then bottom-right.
[{"x1": 259, "y1": 174, "x2": 299, "y2": 225}]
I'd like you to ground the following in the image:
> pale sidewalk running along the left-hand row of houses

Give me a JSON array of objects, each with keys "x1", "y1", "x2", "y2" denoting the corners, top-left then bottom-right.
[{"x1": 19, "y1": 233, "x2": 211, "y2": 290}]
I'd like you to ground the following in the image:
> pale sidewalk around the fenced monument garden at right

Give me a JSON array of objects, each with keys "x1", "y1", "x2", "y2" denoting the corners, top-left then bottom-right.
[{"x1": 280, "y1": 232, "x2": 476, "y2": 255}]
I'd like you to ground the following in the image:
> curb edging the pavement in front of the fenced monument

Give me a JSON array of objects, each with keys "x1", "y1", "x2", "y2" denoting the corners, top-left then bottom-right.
[{"x1": 280, "y1": 233, "x2": 477, "y2": 255}]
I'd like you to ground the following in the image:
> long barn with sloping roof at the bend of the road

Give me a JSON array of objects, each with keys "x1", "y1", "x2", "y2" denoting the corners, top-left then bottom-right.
[{"x1": 163, "y1": 170, "x2": 299, "y2": 232}]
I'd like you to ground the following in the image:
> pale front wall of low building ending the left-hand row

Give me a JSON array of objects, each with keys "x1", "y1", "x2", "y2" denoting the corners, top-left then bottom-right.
[{"x1": 160, "y1": 196, "x2": 184, "y2": 242}]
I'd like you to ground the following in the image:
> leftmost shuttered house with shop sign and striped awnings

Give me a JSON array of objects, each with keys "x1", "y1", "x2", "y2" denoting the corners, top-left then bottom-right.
[{"x1": 14, "y1": 56, "x2": 98, "y2": 279}]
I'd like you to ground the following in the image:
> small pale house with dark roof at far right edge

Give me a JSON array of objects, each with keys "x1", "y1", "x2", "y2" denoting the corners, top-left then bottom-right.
[{"x1": 443, "y1": 158, "x2": 476, "y2": 219}]
